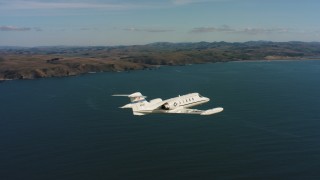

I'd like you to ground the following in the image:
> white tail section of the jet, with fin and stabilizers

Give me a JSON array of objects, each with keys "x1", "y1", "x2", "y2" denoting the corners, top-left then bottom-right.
[{"x1": 113, "y1": 92, "x2": 148, "y2": 115}]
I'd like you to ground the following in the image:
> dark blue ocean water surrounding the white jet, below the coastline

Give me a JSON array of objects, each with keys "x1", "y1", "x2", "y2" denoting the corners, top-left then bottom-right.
[{"x1": 0, "y1": 61, "x2": 320, "y2": 180}]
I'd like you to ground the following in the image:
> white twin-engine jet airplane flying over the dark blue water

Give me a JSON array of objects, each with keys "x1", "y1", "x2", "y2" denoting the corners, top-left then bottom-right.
[{"x1": 112, "y1": 92, "x2": 223, "y2": 116}]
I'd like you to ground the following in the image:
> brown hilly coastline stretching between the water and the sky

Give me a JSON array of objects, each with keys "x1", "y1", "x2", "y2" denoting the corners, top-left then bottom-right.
[{"x1": 0, "y1": 41, "x2": 320, "y2": 80}]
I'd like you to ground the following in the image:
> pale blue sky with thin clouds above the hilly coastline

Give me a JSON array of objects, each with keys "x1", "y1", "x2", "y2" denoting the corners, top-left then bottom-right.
[{"x1": 0, "y1": 0, "x2": 320, "y2": 47}]
